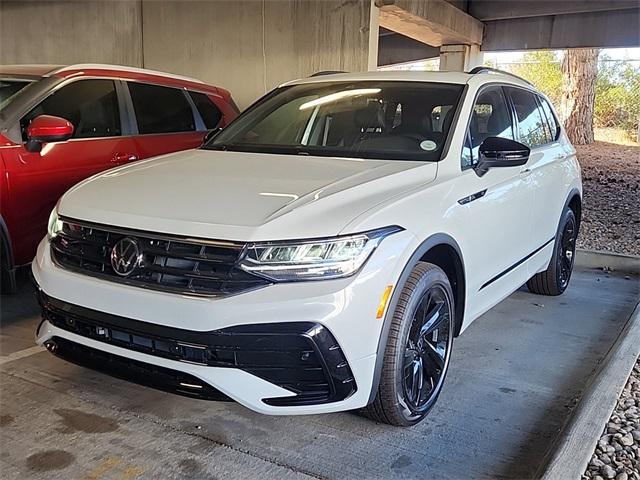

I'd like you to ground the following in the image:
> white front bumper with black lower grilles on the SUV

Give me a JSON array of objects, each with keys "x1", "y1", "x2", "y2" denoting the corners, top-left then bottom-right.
[{"x1": 32, "y1": 232, "x2": 413, "y2": 415}]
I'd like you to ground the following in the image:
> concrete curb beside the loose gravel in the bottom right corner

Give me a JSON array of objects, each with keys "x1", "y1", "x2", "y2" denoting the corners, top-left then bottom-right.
[{"x1": 536, "y1": 303, "x2": 640, "y2": 480}]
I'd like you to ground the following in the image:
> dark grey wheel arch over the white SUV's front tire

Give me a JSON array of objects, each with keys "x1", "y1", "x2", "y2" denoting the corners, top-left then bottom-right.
[{"x1": 368, "y1": 233, "x2": 466, "y2": 403}]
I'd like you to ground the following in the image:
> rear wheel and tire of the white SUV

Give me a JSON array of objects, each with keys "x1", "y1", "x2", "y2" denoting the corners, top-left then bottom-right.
[{"x1": 527, "y1": 208, "x2": 578, "y2": 296}]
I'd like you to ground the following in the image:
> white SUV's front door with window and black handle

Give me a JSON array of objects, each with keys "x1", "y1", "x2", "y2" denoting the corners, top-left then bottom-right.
[{"x1": 456, "y1": 86, "x2": 534, "y2": 319}]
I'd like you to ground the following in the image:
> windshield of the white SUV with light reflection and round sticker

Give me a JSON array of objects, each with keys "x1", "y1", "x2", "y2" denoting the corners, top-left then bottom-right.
[{"x1": 204, "y1": 81, "x2": 463, "y2": 161}]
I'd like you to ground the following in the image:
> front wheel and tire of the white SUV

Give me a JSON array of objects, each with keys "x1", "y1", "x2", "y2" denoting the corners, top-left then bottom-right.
[{"x1": 363, "y1": 262, "x2": 455, "y2": 427}]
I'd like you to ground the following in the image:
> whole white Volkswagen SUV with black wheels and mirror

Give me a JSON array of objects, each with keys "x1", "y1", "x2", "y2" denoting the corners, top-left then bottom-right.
[{"x1": 33, "y1": 69, "x2": 582, "y2": 426}]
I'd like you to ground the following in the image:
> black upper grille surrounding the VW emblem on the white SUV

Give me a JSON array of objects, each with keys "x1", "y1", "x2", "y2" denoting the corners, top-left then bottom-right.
[{"x1": 51, "y1": 219, "x2": 269, "y2": 296}]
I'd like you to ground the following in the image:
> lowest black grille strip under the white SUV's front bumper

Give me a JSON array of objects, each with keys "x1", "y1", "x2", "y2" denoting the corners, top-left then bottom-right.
[{"x1": 48, "y1": 337, "x2": 231, "y2": 401}]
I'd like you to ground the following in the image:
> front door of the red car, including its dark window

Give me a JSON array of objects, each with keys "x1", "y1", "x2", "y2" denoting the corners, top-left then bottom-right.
[{"x1": 2, "y1": 79, "x2": 137, "y2": 265}]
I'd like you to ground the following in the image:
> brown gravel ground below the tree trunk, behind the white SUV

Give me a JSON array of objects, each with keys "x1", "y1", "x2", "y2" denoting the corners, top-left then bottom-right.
[{"x1": 576, "y1": 142, "x2": 640, "y2": 255}]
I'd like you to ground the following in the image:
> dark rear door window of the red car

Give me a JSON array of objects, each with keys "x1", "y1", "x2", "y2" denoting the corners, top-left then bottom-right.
[{"x1": 128, "y1": 82, "x2": 196, "y2": 134}]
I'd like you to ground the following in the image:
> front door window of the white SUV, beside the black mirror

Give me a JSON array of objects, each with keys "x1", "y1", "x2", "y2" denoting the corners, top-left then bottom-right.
[{"x1": 461, "y1": 86, "x2": 515, "y2": 170}]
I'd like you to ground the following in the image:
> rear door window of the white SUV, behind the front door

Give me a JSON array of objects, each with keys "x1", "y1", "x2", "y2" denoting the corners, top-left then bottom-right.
[{"x1": 507, "y1": 88, "x2": 552, "y2": 148}]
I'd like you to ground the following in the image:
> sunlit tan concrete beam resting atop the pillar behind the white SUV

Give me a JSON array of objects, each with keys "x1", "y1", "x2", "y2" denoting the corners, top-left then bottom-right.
[{"x1": 375, "y1": 0, "x2": 483, "y2": 47}]
